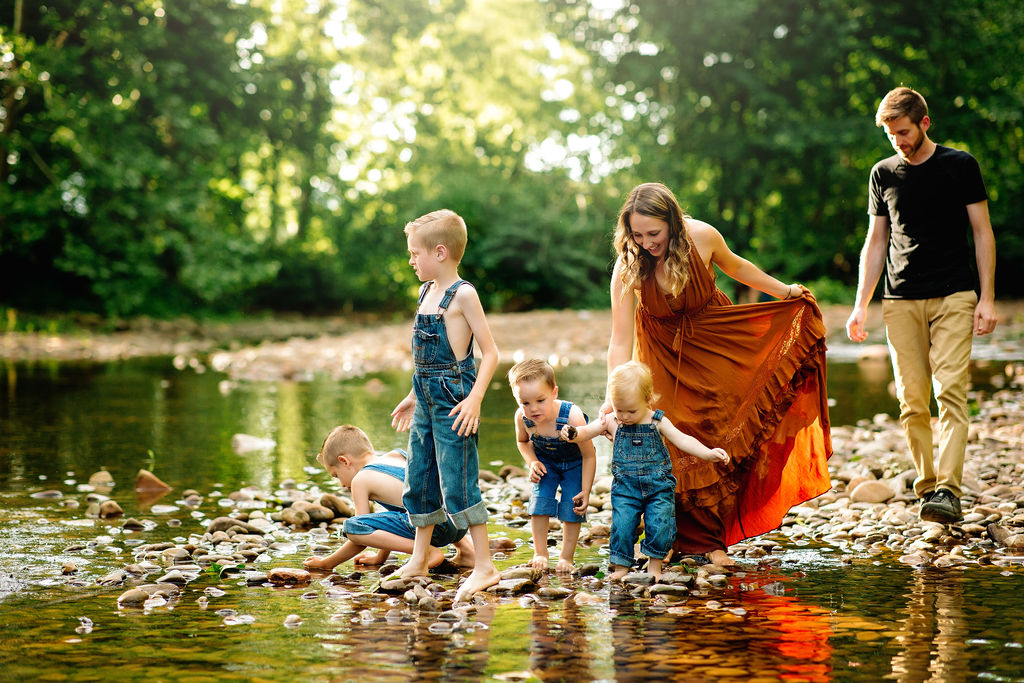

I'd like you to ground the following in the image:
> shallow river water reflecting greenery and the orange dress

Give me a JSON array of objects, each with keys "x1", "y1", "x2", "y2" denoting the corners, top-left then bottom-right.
[{"x1": 0, "y1": 358, "x2": 1024, "y2": 681}]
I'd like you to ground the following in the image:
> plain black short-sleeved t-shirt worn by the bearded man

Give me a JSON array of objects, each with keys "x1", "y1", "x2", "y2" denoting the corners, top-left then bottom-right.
[{"x1": 867, "y1": 144, "x2": 988, "y2": 299}]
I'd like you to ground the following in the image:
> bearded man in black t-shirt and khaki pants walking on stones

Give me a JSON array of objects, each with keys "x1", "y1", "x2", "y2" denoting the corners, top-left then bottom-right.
[{"x1": 846, "y1": 87, "x2": 995, "y2": 523}]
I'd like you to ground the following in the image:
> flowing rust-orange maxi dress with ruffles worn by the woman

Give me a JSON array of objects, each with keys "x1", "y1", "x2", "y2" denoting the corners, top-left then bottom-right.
[{"x1": 635, "y1": 242, "x2": 831, "y2": 553}]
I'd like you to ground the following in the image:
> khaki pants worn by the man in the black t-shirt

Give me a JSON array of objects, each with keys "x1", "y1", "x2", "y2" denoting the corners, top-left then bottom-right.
[{"x1": 882, "y1": 291, "x2": 978, "y2": 498}]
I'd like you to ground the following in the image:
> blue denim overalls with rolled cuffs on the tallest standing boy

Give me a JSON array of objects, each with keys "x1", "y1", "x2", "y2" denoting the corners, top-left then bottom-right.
[{"x1": 401, "y1": 280, "x2": 487, "y2": 529}]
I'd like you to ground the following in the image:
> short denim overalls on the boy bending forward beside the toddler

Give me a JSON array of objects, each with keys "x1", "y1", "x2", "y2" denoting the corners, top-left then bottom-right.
[{"x1": 522, "y1": 400, "x2": 589, "y2": 522}]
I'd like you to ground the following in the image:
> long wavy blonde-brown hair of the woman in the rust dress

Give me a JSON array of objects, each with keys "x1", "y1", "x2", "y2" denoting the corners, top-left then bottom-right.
[{"x1": 614, "y1": 182, "x2": 690, "y2": 296}]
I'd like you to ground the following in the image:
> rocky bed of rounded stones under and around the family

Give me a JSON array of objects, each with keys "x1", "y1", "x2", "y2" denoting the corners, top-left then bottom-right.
[{"x1": 22, "y1": 367, "x2": 1024, "y2": 618}]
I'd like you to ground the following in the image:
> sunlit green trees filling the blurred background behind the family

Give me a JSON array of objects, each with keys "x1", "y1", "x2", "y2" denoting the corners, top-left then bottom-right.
[{"x1": 0, "y1": 0, "x2": 1024, "y2": 315}]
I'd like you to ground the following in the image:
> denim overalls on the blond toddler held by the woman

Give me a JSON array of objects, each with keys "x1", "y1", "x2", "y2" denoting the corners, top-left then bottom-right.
[{"x1": 608, "y1": 411, "x2": 676, "y2": 567}]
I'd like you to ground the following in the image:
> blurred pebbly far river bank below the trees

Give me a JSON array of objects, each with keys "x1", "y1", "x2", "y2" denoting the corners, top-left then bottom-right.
[{"x1": 8, "y1": 301, "x2": 1024, "y2": 380}]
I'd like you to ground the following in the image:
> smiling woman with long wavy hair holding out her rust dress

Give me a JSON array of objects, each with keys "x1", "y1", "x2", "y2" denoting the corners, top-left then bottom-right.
[{"x1": 601, "y1": 183, "x2": 831, "y2": 565}]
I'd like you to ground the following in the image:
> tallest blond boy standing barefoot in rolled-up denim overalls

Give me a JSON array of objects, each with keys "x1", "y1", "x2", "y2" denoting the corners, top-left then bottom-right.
[{"x1": 391, "y1": 209, "x2": 499, "y2": 601}]
